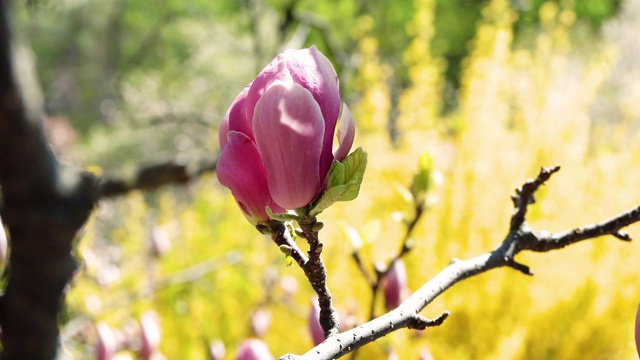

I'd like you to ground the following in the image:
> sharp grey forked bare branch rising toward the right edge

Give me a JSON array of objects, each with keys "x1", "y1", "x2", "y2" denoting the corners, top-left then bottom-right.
[{"x1": 280, "y1": 167, "x2": 640, "y2": 360}]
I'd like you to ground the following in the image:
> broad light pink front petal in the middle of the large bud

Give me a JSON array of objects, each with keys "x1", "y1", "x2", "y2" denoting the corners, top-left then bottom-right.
[{"x1": 253, "y1": 81, "x2": 324, "y2": 209}]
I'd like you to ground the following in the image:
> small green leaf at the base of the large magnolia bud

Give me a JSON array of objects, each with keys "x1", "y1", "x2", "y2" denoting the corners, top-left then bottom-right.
[{"x1": 309, "y1": 148, "x2": 367, "y2": 216}]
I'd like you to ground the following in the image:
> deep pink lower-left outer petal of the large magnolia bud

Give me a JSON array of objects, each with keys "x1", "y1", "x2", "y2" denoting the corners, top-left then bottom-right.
[{"x1": 216, "y1": 131, "x2": 284, "y2": 224}]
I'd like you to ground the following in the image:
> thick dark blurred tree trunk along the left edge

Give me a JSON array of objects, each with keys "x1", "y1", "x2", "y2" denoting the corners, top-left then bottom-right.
[{"x1": 0, "y1": 1, "x2": 95, "y2": 360}]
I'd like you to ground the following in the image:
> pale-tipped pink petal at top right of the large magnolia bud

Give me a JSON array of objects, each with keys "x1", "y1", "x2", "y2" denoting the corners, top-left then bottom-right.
[{"x1": 282, "y1": 46, "x2": 340, "y2": 177}]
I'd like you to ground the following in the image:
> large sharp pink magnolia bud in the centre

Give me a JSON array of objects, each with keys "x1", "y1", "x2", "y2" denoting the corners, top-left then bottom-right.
[{"x1": 217, "y1": 46, "x2": 355, "y2": 224}]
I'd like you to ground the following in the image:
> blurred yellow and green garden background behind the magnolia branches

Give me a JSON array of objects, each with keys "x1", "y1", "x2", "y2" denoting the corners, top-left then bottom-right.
[{"x1": 16, "y1": 0, "x2": 640, "y2": 359}]
